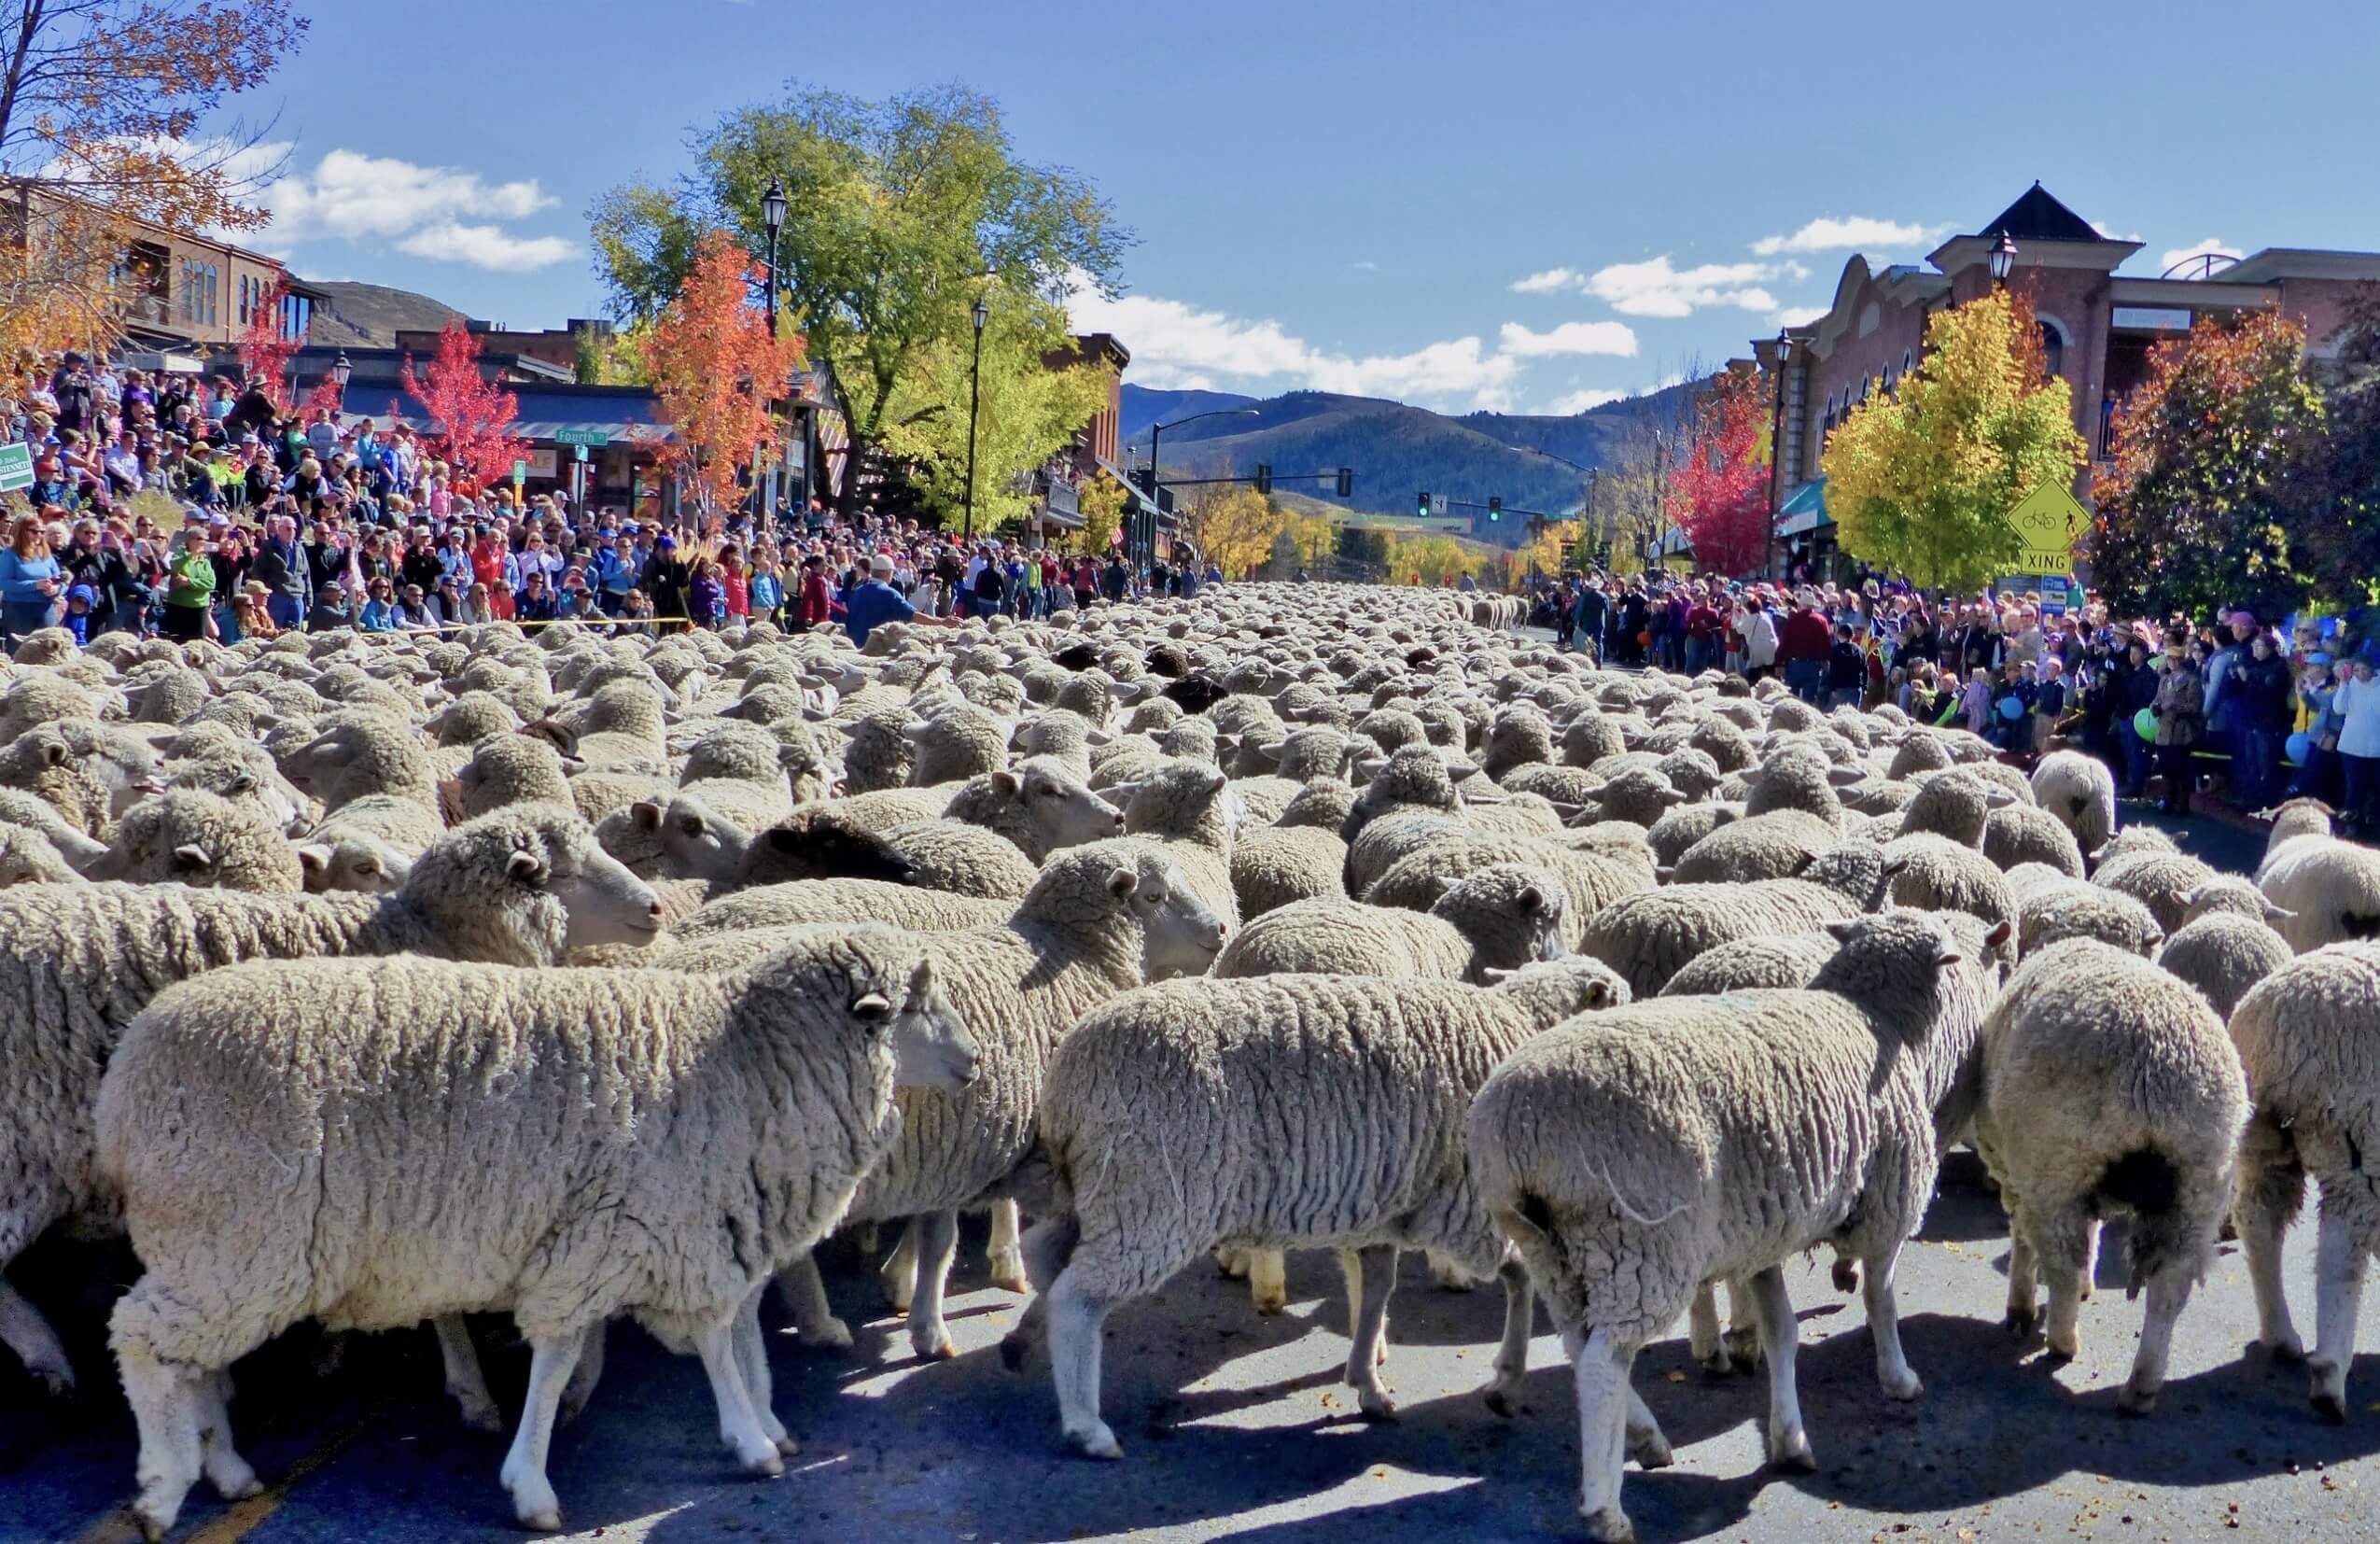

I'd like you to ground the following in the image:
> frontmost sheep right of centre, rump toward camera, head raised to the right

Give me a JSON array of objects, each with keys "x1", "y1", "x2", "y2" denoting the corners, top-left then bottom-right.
[{"x1": 1466, "y1": 908, "x2": 1985, "y2": 1541}]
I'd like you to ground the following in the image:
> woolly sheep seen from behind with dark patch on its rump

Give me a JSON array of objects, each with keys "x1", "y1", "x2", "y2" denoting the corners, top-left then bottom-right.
[{"x1": 1976, "y1": 940, "x2": 2247, "y2": 1413}]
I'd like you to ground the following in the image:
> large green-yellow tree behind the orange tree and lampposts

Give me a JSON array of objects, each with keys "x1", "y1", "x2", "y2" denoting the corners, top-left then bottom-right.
[{"x1": 588, "y1": 86, "x2": 1130, "y2": 512}]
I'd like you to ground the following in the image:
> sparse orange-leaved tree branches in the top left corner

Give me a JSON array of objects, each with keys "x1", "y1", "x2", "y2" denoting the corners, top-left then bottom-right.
[{"x1": 0, "y1": 0, "x2": 307, "y2": 347}]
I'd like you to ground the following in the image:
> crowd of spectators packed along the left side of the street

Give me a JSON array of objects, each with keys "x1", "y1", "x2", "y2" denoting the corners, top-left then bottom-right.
[{"x1": 0, "y1": 352, "x2": 1219, "y2": 647}]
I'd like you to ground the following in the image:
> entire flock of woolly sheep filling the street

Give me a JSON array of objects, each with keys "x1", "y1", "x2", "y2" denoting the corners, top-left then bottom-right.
[{"x1": 0, "y1": 585, "x2": 2380, "y2": 1539}]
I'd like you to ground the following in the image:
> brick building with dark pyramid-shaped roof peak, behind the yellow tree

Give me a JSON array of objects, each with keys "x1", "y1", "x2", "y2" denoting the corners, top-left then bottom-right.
[{"x1": 1752, "y1": 183, "x2": 2380, "y2": 573}]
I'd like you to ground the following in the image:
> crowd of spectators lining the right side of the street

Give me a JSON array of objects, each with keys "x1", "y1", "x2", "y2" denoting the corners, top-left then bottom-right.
[{"x1": 1537, "y1": 573, "x2": 2380, "y2": 833}]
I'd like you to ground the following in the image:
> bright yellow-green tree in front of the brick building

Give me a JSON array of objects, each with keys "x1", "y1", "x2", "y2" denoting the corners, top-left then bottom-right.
[{"x1": 1823, "y1": 290, "x2": 2090, "y2": 590}]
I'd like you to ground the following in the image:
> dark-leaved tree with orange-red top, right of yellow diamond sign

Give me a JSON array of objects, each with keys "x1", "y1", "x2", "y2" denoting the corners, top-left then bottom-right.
[{"x1": 2090, "y1": 312, "x2": 2328, "y2": 616}]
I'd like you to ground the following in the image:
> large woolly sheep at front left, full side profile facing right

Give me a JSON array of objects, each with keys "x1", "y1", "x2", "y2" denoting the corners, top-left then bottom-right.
[{"x1": 98, "y1": 928, "x2": 976, "y2": 1537}]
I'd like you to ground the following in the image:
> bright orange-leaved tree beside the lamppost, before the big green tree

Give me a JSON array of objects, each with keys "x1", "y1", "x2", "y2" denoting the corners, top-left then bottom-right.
[{"x1": 645, "y1": 231, "x2": 802, "y2": 513}]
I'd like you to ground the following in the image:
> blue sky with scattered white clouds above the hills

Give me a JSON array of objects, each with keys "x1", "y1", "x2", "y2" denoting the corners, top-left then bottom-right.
[{"x1": 247, "y1": 0, "x2": 2380, "y2": 412}]
